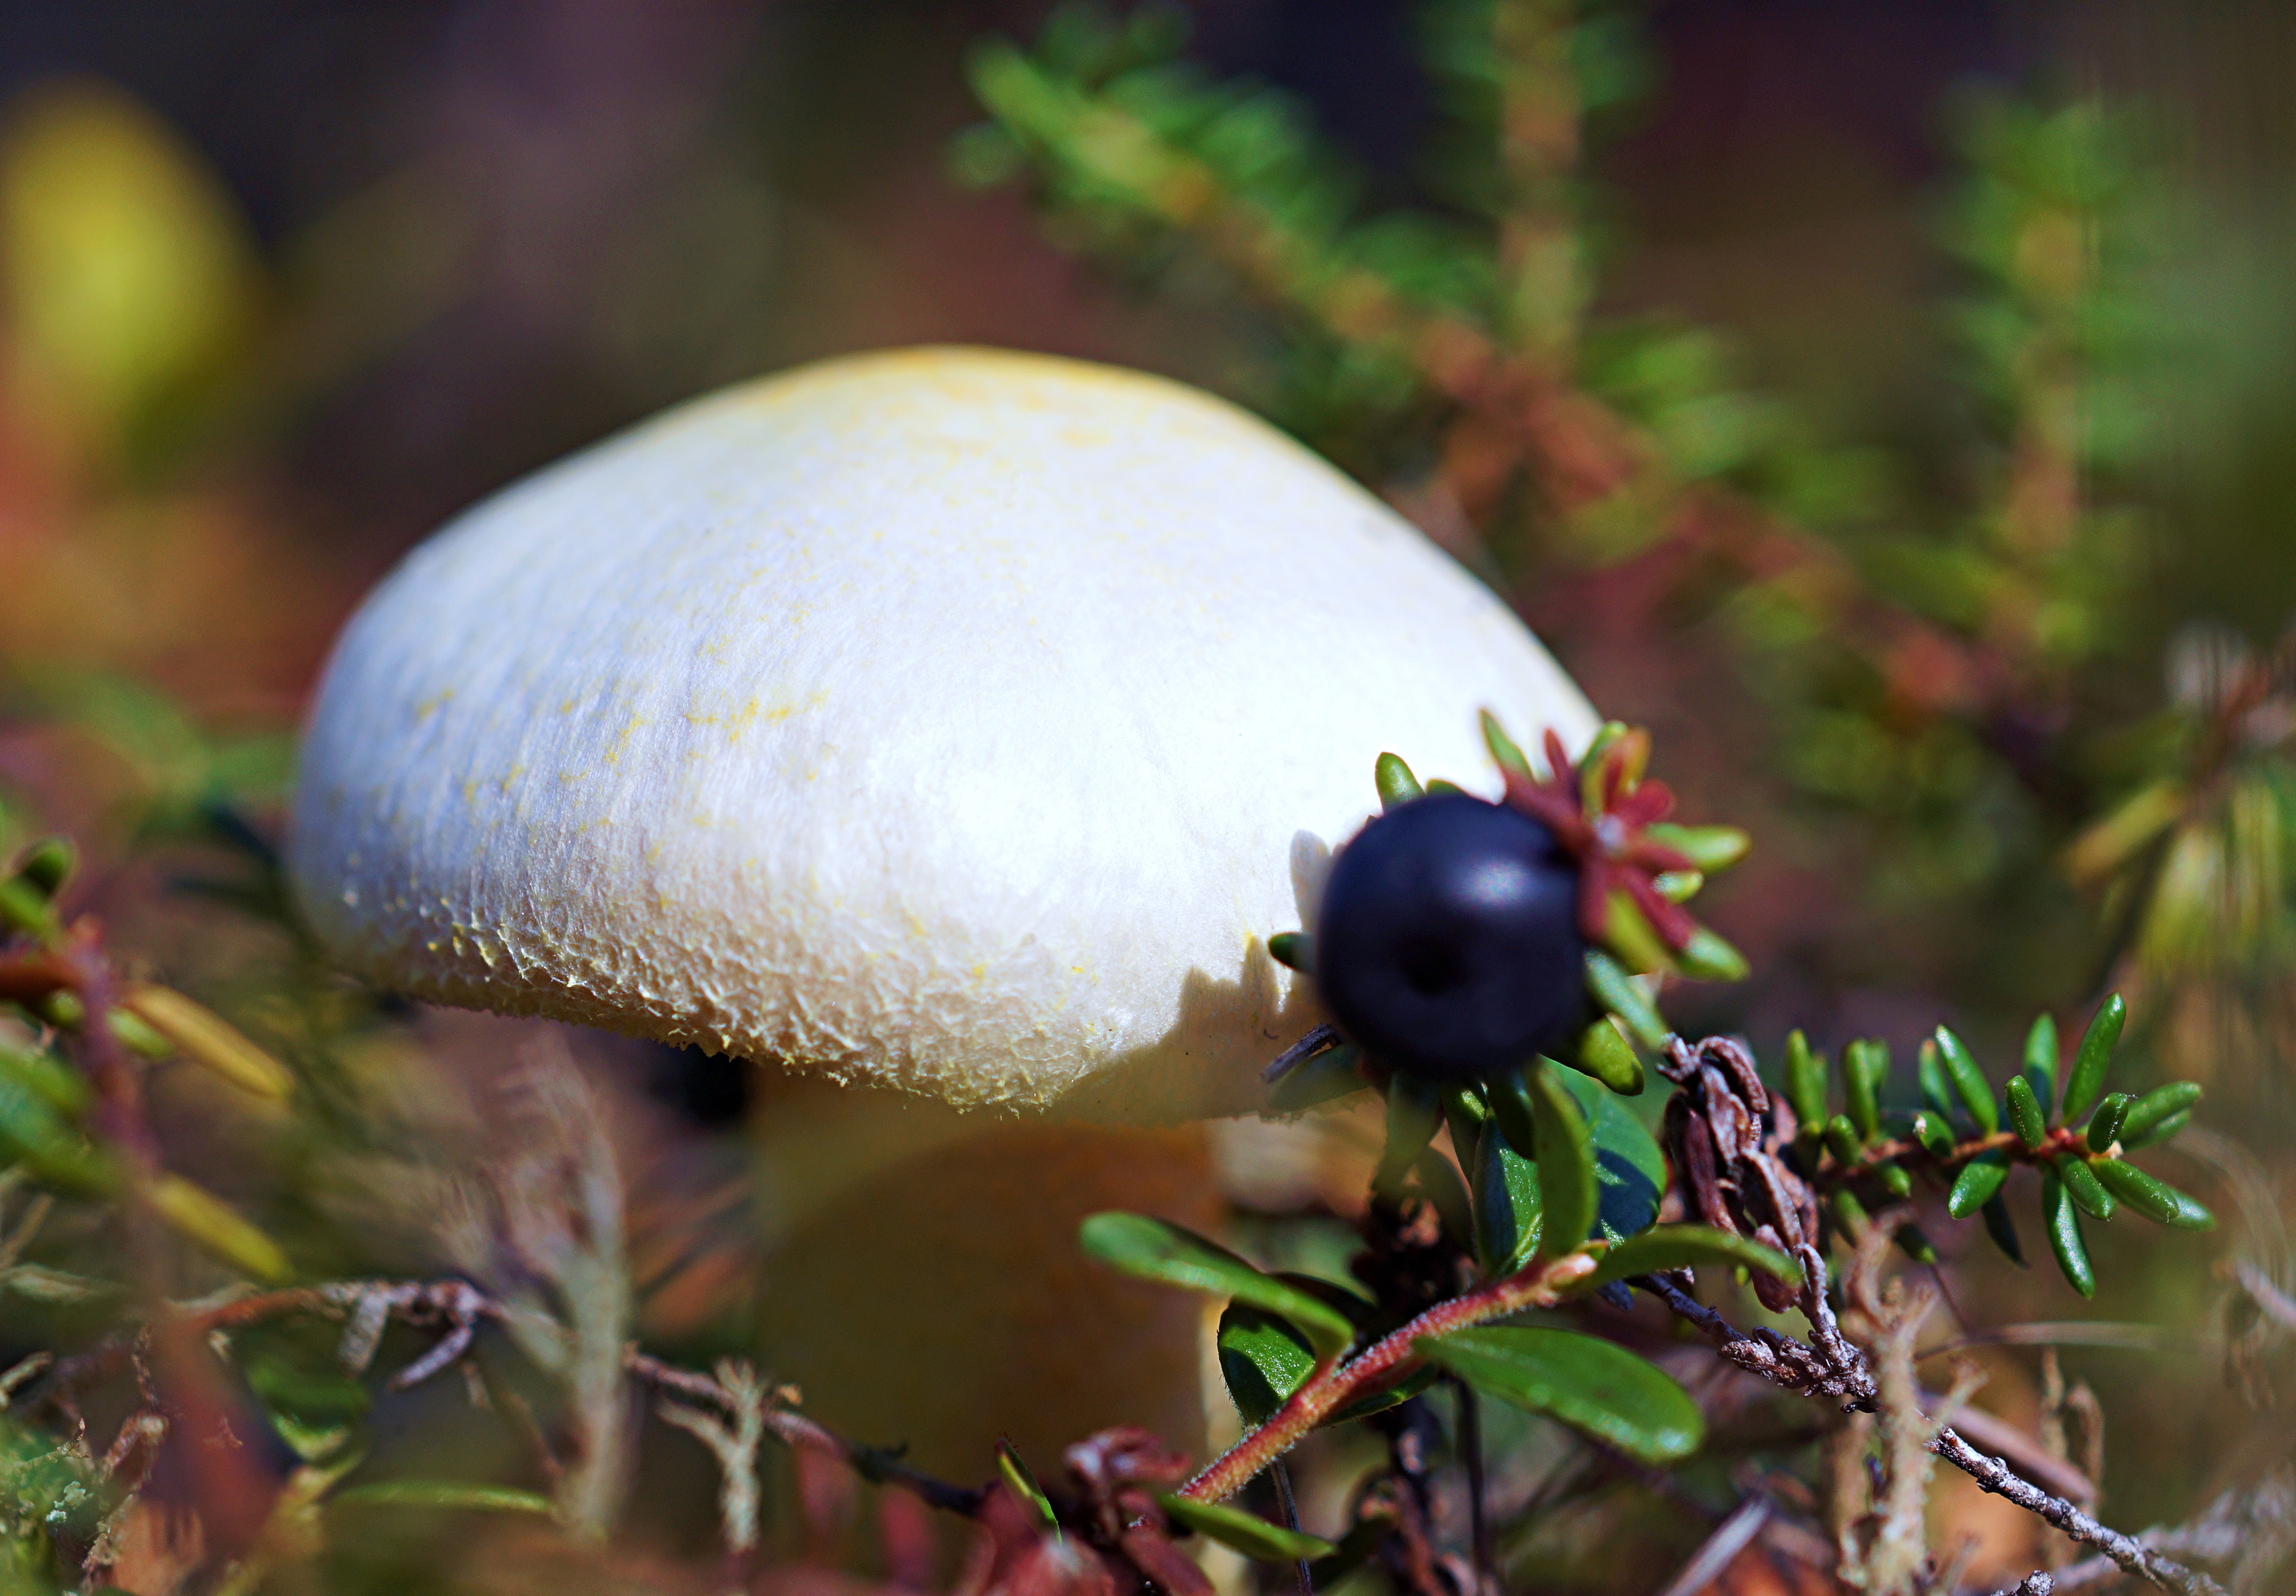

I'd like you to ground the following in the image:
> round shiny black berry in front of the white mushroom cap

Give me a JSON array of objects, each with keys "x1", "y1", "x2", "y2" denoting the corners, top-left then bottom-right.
[{"x1": 1316, "y1": 795, "x2": 1586, "y2": 1081}]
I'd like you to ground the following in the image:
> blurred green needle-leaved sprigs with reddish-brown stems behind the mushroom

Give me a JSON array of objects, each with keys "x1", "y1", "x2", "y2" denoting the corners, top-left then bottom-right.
[{"x1": 953, "y1": 2, "x2": 2289, "y2": 1068}]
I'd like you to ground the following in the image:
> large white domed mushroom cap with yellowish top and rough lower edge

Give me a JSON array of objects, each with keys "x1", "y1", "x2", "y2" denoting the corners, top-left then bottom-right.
[{"x1": 289, "y1": 349, "x2": 1596, "y2": 1123}]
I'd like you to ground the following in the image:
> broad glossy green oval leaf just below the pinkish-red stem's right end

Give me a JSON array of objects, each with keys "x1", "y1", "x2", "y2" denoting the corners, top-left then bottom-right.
[{"x1": 1412, "y1": 1325, "x2": 1706, "y2": 1463}]
